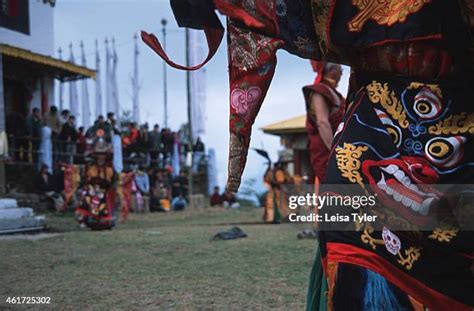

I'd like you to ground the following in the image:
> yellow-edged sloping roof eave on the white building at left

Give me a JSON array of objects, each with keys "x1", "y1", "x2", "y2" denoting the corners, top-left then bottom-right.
[{"x1": 0, "y1": 44, "x2": 96, "y2": 81}]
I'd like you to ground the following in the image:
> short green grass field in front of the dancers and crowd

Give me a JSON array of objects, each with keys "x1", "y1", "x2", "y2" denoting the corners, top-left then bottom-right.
[{"x1": 0, "y1": 209, "x2": 316, "y2": 310}]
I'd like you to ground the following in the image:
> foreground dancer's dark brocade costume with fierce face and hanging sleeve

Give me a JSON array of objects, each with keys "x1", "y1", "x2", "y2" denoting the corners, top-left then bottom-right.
[{"x1": 142, "y1": 0, "x2": 474, "y2": 310}]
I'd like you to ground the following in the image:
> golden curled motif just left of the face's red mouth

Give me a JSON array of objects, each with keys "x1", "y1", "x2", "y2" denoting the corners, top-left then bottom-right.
[{"x1": 336, "y1": 143, "x2": 368, "y2": 189}]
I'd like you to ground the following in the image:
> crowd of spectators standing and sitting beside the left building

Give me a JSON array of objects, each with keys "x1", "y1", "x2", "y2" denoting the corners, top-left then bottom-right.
[{"x1": 7, "y1": 106, "x2": 209, "y2": 211}]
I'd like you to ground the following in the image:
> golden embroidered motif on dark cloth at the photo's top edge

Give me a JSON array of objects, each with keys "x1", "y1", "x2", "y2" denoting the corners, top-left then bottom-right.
[{"x1": 348, "y1": 0, "x2": 431, "y2": 32}]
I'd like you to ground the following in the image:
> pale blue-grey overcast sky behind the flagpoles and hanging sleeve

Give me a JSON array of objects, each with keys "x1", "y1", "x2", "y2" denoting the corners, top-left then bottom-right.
[{"x1": 55, "y1": 0, "x2": 347, "y2": 191}]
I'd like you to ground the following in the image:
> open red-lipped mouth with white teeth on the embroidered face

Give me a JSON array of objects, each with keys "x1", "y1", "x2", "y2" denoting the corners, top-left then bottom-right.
[{"x1": 362, "y1": 156, "x2": 441, "y2": 225}]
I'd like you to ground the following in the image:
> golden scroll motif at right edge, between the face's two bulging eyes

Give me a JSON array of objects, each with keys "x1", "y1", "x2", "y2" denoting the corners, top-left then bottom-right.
[{"x1": 428, "y1": 112, "x2": 474, "y2": 135}]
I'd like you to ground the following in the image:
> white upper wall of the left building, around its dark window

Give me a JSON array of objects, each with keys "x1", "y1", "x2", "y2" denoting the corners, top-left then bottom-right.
[{"x1": 0, "y1": 0, "x2": 54, "y2": 56}]
